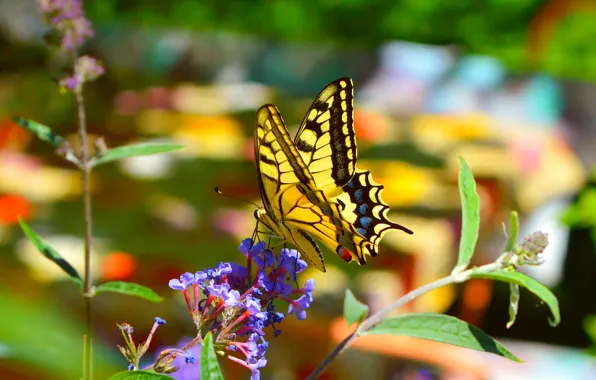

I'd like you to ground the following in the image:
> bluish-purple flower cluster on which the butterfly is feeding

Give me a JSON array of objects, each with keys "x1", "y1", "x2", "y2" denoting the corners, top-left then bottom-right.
[{"x1": 169, "y1": 239, "x2": 315, "y2": 380}]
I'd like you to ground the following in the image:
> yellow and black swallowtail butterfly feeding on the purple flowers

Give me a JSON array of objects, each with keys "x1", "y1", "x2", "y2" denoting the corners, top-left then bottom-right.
[{"x1": 255, "y1": 78, "x2": 413, "y2": 272}]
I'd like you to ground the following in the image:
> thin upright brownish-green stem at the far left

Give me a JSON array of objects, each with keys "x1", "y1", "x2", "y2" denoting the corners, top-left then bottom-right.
[{"x1": 72, "y1": 52, "x2": 92, "y2": 380}]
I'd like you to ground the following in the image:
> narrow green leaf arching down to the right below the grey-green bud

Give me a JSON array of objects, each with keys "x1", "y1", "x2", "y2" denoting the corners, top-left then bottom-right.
[{"x1": 470, "y1": 270, "x2": 561, "y2": 327}]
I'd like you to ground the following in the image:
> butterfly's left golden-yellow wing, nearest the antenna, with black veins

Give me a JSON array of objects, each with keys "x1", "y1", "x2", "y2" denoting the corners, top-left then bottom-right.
[{"x1": 255, "y1": 105, "x2": 332, "y2": 272}]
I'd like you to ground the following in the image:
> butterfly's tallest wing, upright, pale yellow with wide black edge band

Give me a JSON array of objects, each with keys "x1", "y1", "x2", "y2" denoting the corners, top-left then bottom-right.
[{"x1": 294, "y1": 78, "x2": 358, "y2": 197}]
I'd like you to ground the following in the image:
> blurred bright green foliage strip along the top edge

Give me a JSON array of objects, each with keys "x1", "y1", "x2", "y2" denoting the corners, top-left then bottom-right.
[{"x1": 86, "y1": 0, "x2": 596, "y2": 79}]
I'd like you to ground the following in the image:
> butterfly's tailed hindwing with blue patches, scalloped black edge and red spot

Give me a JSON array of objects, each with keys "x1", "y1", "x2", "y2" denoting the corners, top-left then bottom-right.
[{"x1": 335, "y1": 170, "x2": 413, "y2": 265}]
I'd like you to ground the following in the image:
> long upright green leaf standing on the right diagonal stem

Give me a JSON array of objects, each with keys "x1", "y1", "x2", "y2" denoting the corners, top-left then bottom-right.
[{"x1": 454, "y1": 157, "x2": 480, "y2": 272}]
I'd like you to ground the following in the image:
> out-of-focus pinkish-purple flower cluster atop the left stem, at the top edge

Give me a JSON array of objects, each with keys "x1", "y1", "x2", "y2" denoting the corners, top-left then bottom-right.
[{"x1": 37, "y1": 0, "x2": 95, "y2": 51}]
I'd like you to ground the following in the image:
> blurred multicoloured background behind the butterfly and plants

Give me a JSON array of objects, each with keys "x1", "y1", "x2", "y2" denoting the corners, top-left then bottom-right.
[{"x1": 0, "y1": 0, "x2": 596, "y2": 380}]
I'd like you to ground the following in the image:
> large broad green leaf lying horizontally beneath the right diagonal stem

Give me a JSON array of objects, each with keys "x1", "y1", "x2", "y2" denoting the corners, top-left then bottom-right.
[{"x1": 364, "y1": 313, "x2": 521, "y2": 362}]
